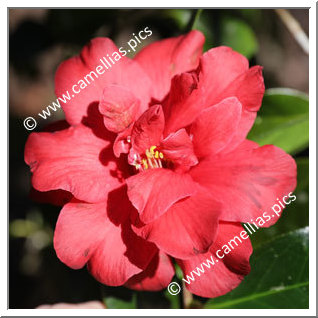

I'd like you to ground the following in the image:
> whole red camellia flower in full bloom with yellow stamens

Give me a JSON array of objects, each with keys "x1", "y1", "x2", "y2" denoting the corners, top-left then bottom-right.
[{"x1": 25, "y1": 31, "x2": 296, "y2": 297}]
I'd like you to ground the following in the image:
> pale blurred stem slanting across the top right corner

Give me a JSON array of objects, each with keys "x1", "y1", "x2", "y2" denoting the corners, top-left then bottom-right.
[{"x1": 275, "y1": 9, "x2": 309, "y2": 54}]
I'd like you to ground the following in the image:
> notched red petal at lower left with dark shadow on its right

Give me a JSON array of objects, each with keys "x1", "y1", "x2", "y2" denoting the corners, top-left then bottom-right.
[{"x1": 54, "y1": 202, "x2": 157, "y2": 286}]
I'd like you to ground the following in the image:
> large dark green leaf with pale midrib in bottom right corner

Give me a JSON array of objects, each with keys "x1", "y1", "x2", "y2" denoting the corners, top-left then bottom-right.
[{"x1": 205, "y1": 227, "x2": 309, "y2": 309}]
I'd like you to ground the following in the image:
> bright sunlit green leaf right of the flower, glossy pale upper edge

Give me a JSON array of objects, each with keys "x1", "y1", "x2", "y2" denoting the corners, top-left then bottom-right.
[{"x1": 248, "y1": 88, "x2": 309, "y2": 154}]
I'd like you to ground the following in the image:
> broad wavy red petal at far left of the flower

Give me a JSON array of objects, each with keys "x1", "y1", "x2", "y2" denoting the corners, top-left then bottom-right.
[{"x1": 25, "y1": 125, "x2": 128, "y2": 202}]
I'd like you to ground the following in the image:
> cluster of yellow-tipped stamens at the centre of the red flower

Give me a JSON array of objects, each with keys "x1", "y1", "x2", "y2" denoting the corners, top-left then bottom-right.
[{"x1": 133, "y1": 146, "x2": 166, "y2": 171}]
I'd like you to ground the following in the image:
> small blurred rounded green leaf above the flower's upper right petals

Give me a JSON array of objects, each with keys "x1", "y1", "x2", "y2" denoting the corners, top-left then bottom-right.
[{"x1": 221, "y1": 17, "x2": 258, "y2": 58}]
